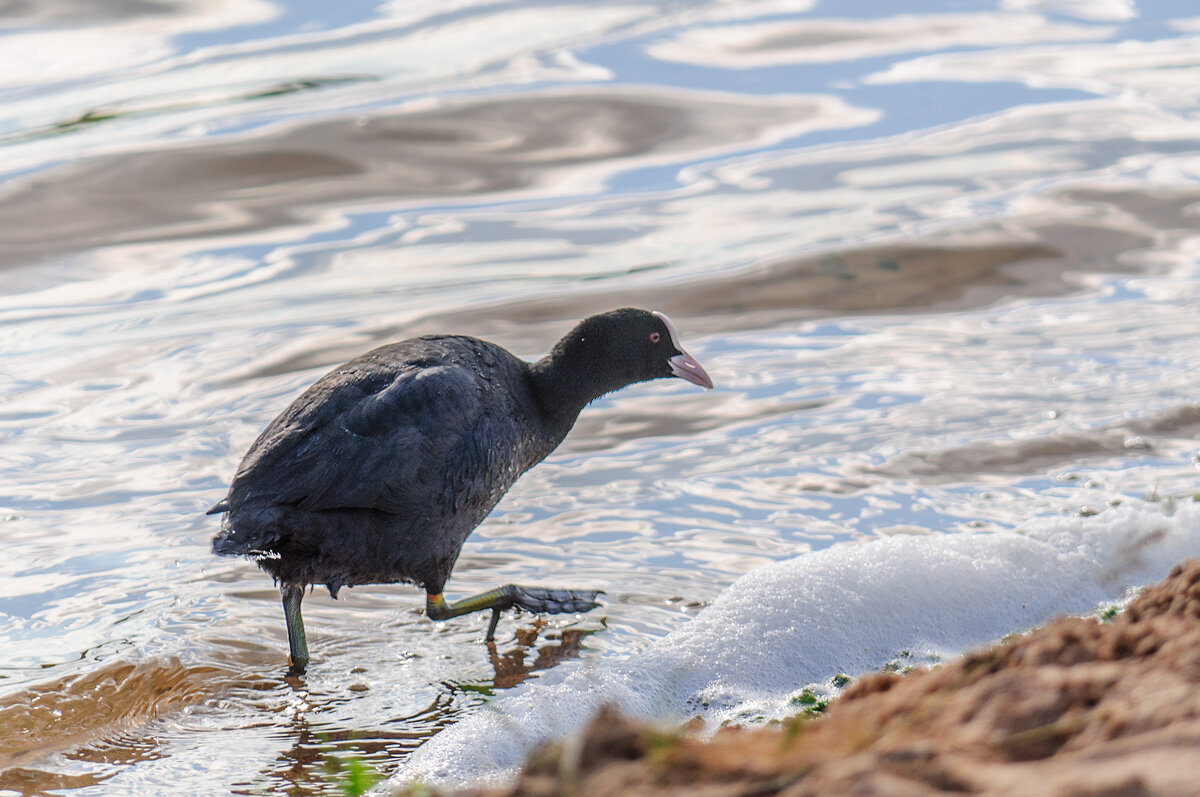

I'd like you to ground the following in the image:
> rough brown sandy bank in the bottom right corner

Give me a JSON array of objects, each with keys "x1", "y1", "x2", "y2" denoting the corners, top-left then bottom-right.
[{"x1": 427, "y1": 559, "x2": 1200, "y2": 797}]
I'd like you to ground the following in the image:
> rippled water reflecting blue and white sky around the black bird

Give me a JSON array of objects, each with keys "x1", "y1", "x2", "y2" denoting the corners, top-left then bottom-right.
[{"x1": 0, "y1": 0, "x2": 1200, "y2": 795}]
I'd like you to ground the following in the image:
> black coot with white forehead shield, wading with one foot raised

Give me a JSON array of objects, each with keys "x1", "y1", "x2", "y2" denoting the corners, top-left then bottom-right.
[{"x1": 208, "y1": 308, "x2": 713, "y2": 673}]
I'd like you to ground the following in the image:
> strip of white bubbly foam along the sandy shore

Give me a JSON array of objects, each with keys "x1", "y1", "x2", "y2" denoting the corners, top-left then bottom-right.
[{"x1": 391, "y1": 502, "x2": 1200, "y2": 786}]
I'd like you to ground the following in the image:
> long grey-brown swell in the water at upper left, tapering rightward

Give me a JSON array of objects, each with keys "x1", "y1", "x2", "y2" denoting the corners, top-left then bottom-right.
[{"x1": 0, "y1": 89, "x2": 871, "y2": 265}]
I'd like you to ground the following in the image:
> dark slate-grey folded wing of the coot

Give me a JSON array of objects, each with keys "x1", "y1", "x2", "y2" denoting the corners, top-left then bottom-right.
[{"x1": 226, "y1": 364, "x2": 511, "y2": 514}]
